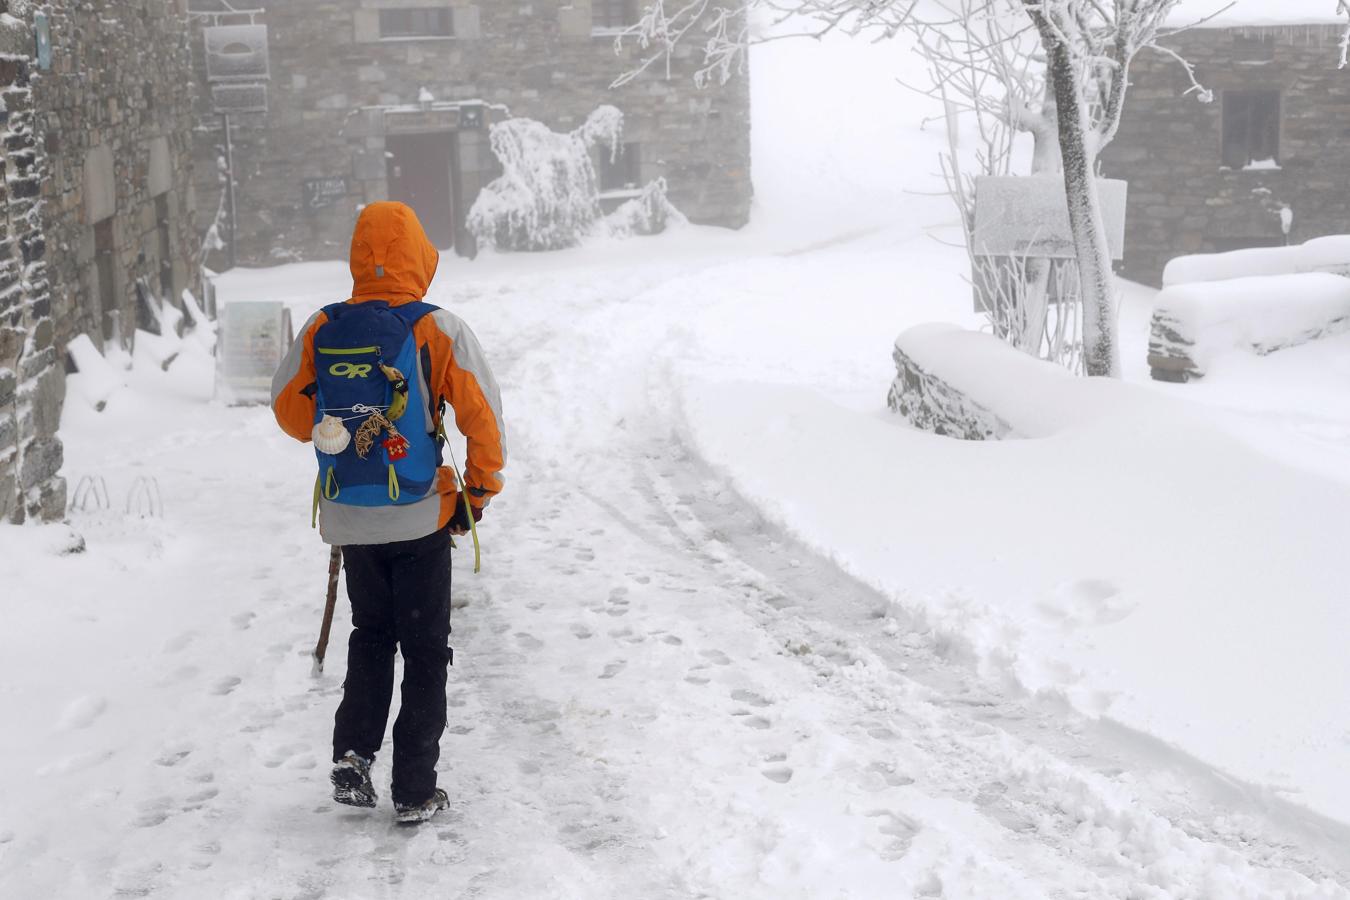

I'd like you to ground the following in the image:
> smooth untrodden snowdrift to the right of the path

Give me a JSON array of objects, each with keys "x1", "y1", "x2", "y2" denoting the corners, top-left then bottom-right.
[{"x1": 682, "y1": 330, "x2": 1350, "y2": 820}]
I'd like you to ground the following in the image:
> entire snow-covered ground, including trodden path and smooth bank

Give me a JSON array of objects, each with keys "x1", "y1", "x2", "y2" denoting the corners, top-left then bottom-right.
[{"x1": 0, "y1": 28, "x2": 1350, "y2": 900}]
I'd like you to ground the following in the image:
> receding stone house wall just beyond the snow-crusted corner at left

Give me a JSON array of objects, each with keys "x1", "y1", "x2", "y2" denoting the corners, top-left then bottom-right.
[{"x1": 34, "y1": 0, "x2": 200, "y2": 356}]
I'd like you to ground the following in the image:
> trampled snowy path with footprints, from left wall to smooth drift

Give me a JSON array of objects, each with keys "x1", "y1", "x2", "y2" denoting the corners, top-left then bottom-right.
[{"x1": 0, "y1": 242, "x2": 1350, "y2": 900}]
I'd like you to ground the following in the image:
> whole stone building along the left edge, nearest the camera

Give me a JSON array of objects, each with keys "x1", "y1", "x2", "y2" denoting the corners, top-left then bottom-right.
[{"x1": 0, "y1": 0, "x2": 200, "y2": 521}]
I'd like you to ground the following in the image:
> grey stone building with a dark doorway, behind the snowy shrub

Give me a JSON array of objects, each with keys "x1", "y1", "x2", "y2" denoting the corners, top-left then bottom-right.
[{"x1": 184, "y1": 0, "x2": 751, "y2": 264}]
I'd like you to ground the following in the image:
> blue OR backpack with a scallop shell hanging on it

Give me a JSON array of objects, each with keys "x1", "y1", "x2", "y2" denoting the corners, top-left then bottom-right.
[{"x1": 313, "y1": 300, "x2": 441, "y2": 507}]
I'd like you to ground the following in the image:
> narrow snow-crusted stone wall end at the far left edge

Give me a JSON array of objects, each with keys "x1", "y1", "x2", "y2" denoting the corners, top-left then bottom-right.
[{"x1": 0, "y1": 9, "x2": 66, "y2": 522}]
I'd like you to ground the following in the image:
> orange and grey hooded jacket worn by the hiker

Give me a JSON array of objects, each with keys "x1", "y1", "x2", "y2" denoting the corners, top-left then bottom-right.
[{"x1": 271, "y1": 202, "x2": 506, "y2": 544}]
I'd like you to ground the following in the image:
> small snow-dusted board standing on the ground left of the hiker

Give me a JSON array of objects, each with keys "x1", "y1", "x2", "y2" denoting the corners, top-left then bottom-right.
[{"x1": 216, "y1": 301, "x2": 294, "y2": 405}]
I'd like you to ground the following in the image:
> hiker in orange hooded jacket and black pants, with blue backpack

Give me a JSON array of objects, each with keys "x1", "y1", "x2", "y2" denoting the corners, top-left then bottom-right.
[{"x1": 271, "y1": 202, "x2": 506, "y2": 823}]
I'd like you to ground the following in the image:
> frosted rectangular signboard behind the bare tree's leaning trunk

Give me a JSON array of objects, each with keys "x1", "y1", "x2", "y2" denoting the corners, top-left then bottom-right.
[{"x1": 972, "y1": 173, "x2": 1126, "y2": 259}]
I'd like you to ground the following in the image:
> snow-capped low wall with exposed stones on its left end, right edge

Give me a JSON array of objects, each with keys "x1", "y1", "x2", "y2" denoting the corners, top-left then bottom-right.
[{"x1": 1149, "y1": 271, "x2": 1350, "y2": 382}]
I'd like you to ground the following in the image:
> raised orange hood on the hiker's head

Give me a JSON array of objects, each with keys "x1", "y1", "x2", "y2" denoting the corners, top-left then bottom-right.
[{"x1": 351, "y1": 201, "x2": 440, "y2": 305}]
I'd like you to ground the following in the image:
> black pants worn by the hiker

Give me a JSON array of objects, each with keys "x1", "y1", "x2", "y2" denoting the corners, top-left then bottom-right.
[{"x1": 333, "y1": 529, "x2": 451, "y2": 804}]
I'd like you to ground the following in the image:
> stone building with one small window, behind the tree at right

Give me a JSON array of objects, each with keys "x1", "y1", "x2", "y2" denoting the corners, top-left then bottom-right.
[{"x1": 1102, "y1": 10, "x2": 1350, "y2": 285}]
